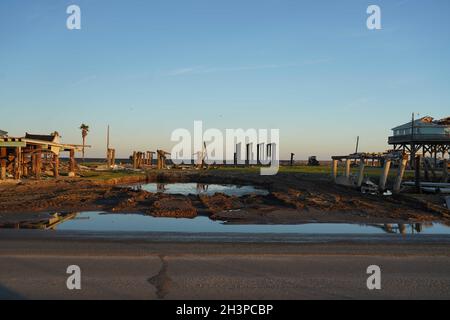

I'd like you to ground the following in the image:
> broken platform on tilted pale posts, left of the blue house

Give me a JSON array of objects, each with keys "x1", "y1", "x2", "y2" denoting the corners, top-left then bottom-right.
[{"x1": 331, "y1": 152, "x2": 408, "y2": 193}]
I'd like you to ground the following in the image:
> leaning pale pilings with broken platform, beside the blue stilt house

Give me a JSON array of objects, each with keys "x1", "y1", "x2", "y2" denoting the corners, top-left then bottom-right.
[{"x1": 331, "y1": 155, "x2": 408, "y2": 193}]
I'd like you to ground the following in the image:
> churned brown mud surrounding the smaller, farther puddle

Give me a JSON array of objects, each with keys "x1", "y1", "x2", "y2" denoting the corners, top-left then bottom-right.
[{"x1": 0, "y1": 170, "x2": 450, "y2": 224}]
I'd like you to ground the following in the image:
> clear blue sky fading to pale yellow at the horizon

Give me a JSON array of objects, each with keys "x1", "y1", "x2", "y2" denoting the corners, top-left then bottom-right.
[{"x1": 0, "y1": 0, "x2": 450, "y2": 159}]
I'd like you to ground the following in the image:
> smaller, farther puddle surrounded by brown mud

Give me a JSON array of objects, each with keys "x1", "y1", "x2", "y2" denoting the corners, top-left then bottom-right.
[{"x1": 133, "y1": 183, "x2": 268, "y2": 197}]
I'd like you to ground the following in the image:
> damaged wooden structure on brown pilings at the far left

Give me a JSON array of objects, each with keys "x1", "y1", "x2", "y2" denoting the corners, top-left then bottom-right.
[{"x1": 0, "y1": 132, "x2": 82, "y2": 180}]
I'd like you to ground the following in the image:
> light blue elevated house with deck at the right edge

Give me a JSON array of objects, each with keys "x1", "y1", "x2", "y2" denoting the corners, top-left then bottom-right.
[{"x1": 388, "y1": 116, "x2": 450, "y2": 161}]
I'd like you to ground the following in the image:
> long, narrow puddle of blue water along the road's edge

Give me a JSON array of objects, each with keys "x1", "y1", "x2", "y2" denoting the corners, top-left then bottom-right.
[{"x1": 52, "y1": 212, "x2": 450, "y2": 234}]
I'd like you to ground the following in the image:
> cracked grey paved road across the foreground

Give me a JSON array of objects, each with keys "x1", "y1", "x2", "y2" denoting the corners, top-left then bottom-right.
[{"x1": 0, "y1": 230, "x2": 450, "y2": 300}]
